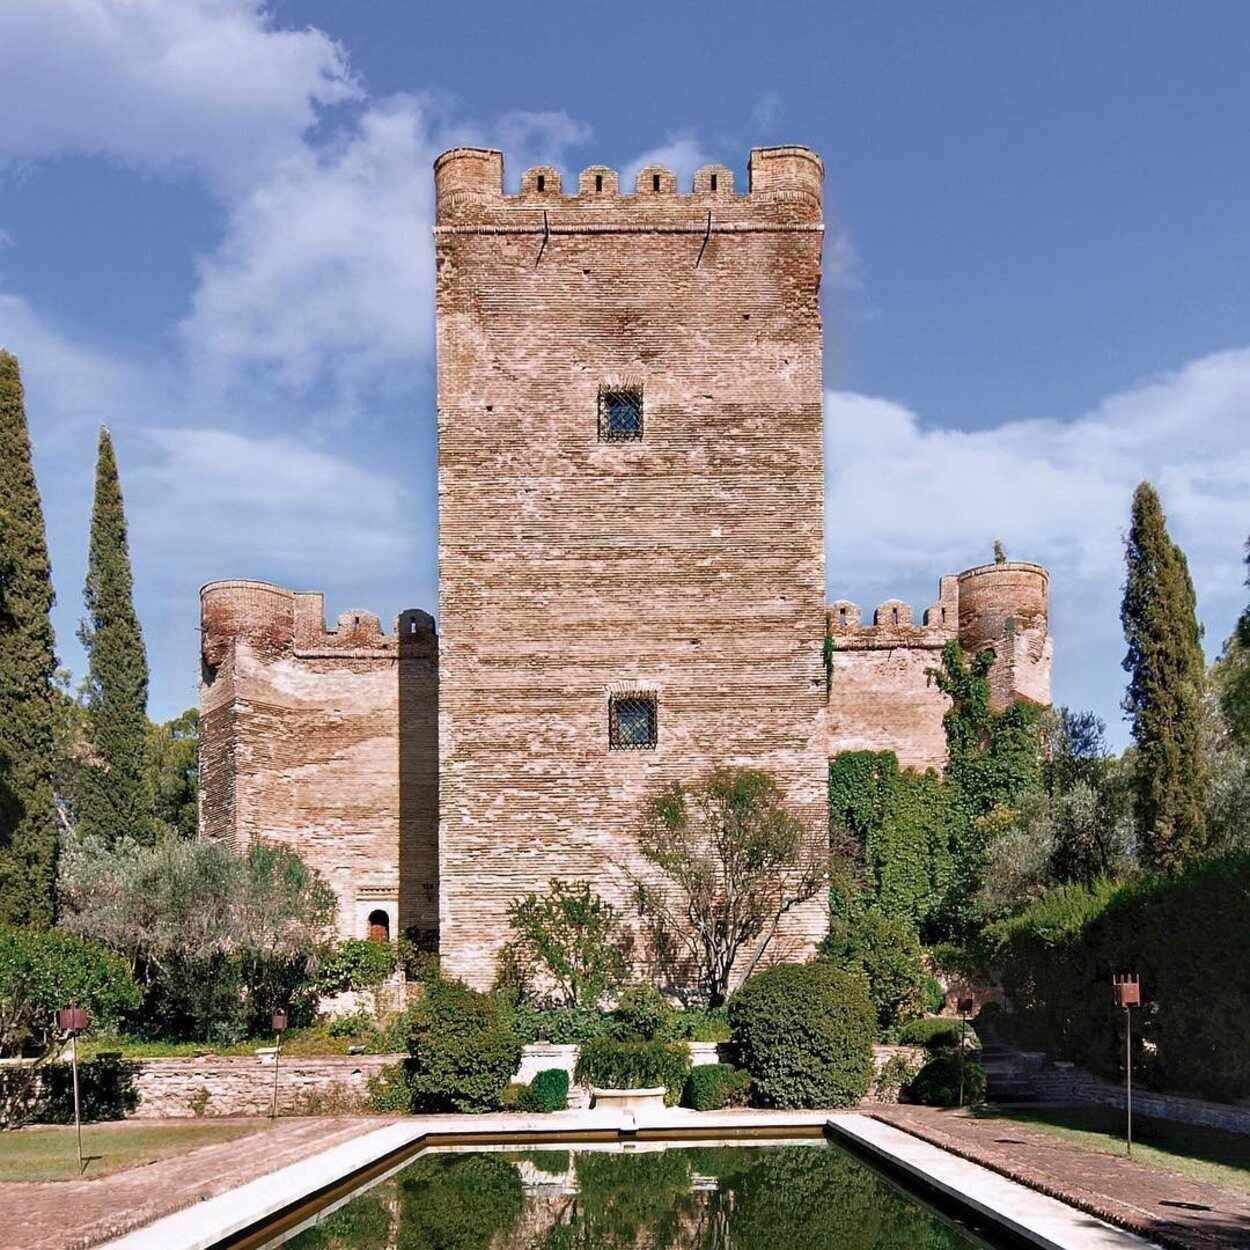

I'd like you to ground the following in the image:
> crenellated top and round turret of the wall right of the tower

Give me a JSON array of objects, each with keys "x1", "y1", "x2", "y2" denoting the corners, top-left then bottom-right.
[{"x1": 826, "y1": 561, "x2": 1051, "y2": 709}]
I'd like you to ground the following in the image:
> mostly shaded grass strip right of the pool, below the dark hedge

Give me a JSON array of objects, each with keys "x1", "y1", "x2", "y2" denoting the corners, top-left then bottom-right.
[{"x1": 978, "y1": 1106, "x2": 1250, "y2": 1193}]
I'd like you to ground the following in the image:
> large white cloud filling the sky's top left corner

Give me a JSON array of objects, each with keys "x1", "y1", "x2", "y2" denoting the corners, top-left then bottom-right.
[{"x1": 0, "y1": 0, "x2": 360, "y2": 194}]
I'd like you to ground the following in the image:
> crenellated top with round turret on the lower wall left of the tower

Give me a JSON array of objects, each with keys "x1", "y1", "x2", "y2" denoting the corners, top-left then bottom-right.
[{"x1": 200, "y1": 579, "x2": 438, "y2": 670}]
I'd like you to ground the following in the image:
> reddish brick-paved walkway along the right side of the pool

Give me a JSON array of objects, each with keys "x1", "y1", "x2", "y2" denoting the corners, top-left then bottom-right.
[{"x1": 865, "y1": 1106, "x2": 1250, "y2": 1250}]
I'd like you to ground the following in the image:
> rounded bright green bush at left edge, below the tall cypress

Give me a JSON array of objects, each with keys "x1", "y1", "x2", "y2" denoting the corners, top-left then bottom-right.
[{"x1": 0, "y1": 926, "x2": 143, "y2": 1055}]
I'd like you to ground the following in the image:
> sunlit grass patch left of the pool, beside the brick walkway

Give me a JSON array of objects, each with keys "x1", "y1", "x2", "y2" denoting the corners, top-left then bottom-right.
[{"x1": 0, "y1": 1120, "x2": 264, "y2": 1181}]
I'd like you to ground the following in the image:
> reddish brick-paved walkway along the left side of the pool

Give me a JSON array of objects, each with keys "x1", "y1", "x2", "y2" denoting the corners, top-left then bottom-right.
[{"x1": 0, "y1": 1116, "x2": 394, "y2": 1250}]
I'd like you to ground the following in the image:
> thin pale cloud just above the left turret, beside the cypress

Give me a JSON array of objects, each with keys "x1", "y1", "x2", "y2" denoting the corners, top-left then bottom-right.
[{"x1": 128, "y1": 429, "x2": 409, "y2": 570}]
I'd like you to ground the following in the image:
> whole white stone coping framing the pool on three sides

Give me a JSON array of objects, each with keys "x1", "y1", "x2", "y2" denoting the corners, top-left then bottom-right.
[{"x1": 104, "y1": 1108, "x2": 1150, "y2": 1250}]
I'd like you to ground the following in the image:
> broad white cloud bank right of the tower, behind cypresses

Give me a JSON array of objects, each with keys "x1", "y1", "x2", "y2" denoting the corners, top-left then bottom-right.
[{"x1": 826, "y1": 348, "x2": 1250, "y2": 720}]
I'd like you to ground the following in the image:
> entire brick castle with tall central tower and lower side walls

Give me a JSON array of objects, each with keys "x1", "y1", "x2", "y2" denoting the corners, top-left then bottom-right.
[{"x1": 200, "y1": 148, "x2": 1051, "y2": 986}]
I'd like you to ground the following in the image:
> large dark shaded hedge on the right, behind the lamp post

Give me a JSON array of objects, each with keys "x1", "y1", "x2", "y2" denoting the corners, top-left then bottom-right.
[{"x1": 985, "y1": 854, "x2": 1250, "y2": 1100}]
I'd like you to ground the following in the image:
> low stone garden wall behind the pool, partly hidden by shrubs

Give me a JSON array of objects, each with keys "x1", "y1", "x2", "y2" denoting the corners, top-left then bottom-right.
[{"x1": 133, "y1": 1041, "x2": 915, "y2": 1119}]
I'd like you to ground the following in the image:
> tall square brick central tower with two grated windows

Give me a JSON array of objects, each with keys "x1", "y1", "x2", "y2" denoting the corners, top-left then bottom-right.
[{"x1": 435, "y1": 148, "x2": 828, "y2": 986}]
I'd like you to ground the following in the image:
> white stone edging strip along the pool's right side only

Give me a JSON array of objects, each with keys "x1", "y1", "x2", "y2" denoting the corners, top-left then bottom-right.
[{"x1": 826, "y1": 1114, "x2": 1158, "y2": 1250}]
